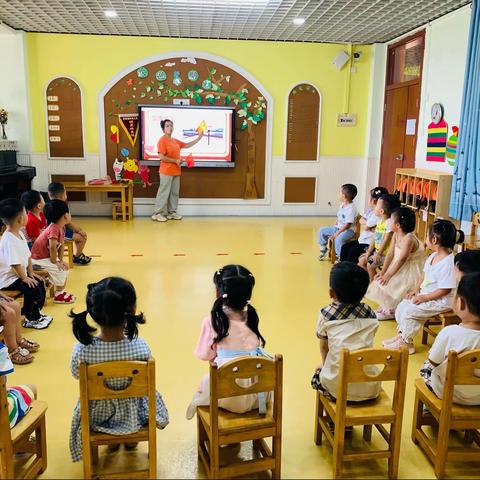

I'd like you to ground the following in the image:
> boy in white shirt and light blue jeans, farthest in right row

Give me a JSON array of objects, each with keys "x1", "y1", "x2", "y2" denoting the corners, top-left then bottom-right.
[{"x1": 318, "y1": 183, "x2": 358, "y2": 260}]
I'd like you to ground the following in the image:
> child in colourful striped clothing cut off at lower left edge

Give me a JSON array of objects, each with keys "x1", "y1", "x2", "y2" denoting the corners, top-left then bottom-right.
[{"x1": 0, "y1": 342, "x2": 37, "y2": 428}]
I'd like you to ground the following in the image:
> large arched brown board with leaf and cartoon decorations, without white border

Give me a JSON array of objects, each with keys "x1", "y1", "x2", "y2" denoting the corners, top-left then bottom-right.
[{"x1": 104, "y1": 57, "x2": 267, "y2": 199}]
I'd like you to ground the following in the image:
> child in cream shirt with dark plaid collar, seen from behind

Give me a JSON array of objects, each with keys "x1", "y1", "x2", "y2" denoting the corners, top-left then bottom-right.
[{"x1": 311, "y1": 262, "x2": 381, "y2": 402}]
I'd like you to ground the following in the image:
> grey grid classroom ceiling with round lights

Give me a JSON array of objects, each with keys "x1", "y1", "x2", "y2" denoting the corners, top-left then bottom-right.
[{"x1": 0, "y1": 0, "x2": 471, "y2": 44}]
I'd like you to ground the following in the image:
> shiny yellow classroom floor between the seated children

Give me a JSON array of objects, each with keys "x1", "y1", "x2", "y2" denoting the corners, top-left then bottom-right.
[{"x1": 8, "y1": 217, "x2": 478, "y2": 478}]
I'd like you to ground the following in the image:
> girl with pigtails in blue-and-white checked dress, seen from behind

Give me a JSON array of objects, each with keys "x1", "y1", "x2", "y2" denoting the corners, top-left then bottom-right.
[{"x1": 70, "y1": 277, "x2": 168, "y2": 462}]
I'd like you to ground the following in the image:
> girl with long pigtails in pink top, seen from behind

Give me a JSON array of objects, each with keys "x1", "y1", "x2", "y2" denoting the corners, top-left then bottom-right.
[{"x1": 186, "y1": 265, "x2": 272, "y2": 420}]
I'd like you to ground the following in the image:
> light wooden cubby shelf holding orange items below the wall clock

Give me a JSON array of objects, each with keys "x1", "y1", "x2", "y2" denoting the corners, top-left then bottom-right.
[{"x1": 395, "y1": 168, "x2": 452, "y2": 243}]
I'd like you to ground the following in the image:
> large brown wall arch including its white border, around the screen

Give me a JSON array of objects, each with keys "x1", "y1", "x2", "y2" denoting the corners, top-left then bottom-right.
[{"x1": 98, "y1": 51, "x2": 273, "y2": 199}]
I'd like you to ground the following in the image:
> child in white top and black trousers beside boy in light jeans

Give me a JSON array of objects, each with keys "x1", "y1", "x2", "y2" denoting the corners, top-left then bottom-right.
[{"x1": 340, "y1": 187, "x2": 388, "y2": 263}]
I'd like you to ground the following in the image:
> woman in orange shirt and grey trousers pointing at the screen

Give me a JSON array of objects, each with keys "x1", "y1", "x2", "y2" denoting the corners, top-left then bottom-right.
[{"x1": 152, "y1": 120, "x2": 203, "y2": 222}]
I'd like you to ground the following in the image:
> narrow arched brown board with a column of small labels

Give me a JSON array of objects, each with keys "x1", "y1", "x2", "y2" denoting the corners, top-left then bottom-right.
[{"x1": 45, "y1": 77, "x2": 85, "y2": 159}]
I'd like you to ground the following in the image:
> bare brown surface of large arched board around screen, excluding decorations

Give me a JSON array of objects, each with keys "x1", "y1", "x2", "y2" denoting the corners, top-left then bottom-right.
[{"x1": 104, "y1": 58, "x2": 267, "y2": 198}]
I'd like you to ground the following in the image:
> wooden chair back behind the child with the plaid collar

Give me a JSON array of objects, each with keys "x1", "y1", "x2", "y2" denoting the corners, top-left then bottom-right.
[{"x1": 337, "y1": 348, "x2": 408, "y2": 415}]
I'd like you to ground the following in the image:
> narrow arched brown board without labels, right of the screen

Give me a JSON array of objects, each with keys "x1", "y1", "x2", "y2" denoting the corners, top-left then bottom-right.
[{"x1": 285, "y1": 81, "x2": 322, "y2": 162}]
